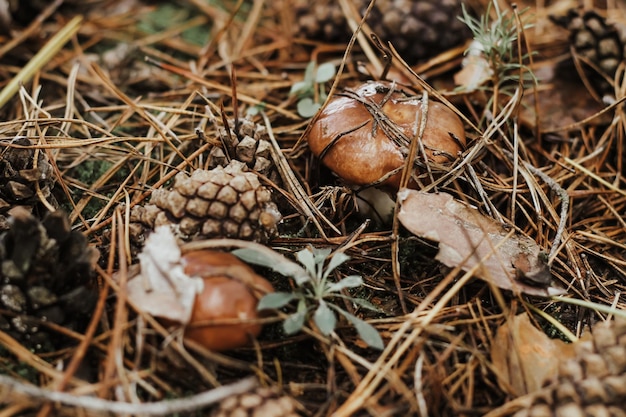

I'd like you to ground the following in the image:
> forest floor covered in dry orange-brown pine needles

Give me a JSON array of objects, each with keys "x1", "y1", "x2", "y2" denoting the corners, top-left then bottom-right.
[{"x1": 0, "y1": 0, "x2": 626, "y2": 416}]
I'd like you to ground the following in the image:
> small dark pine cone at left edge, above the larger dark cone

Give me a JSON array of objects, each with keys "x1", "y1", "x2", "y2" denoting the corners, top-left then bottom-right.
[{"x1": 0, "y1": 137, "x2": 54, "y2": 218}]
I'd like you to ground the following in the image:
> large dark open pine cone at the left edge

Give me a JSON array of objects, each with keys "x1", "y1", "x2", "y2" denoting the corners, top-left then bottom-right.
[{"x1": 0, "y1": 207, "x2": 97, "y2": 350}]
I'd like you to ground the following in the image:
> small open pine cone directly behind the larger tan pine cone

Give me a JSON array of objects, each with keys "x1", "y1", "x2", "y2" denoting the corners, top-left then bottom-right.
[{"x1": 208, "y1": 119, "x2": 279, "y2": 183}]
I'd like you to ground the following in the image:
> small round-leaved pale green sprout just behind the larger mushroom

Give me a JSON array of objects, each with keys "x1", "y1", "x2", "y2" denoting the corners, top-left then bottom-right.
[{"x1": 289, "y1": 61, "x2": 337, "y2": 118}]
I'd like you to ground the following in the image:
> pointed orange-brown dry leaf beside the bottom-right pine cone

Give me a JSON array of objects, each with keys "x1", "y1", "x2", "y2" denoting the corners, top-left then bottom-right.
[{"x1": 491, "y1": 313, "x2": 574, "y2": 396}]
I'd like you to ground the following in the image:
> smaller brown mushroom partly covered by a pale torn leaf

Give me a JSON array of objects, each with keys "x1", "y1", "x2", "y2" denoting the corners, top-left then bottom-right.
[{"x1": 181, "y1": 250, "x2": 274, "y2": 351}]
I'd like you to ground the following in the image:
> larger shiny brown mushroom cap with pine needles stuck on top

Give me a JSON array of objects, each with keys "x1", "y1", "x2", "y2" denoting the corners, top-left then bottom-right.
[{"x1": 307, "y1": 81, "x2": 465, "y2": 190}]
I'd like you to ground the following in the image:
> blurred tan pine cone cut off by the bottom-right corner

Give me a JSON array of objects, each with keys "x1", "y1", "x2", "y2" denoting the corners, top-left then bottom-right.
[{"x1": 514, "y1": 319, "x2": 626, "y2": 417}]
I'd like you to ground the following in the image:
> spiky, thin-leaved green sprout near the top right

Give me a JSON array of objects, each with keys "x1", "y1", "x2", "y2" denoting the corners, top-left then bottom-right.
[{"x1": 459, "y1": 0, "x2": 537, "y2": 114}]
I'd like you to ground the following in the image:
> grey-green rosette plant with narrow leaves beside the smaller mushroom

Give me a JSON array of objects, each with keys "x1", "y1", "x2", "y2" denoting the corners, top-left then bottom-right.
[{"x1": 233, "y1": 247, "x2": 384, "y2": 349}]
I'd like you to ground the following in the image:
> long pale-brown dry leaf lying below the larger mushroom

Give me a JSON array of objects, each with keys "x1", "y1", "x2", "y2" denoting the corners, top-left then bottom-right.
[{"x1": 398, "y1": 189, "x2": 563, "y2": 297}]
